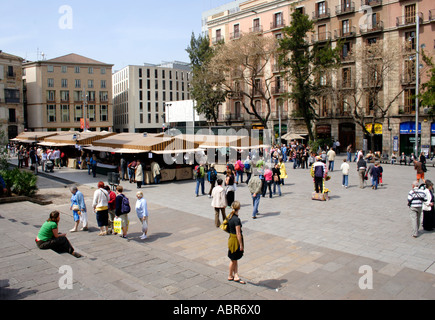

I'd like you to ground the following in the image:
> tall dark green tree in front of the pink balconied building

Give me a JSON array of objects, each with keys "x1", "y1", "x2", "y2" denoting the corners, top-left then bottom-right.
[{"x1": 279, "y1": 10, "x2": 339, "y2": 141}]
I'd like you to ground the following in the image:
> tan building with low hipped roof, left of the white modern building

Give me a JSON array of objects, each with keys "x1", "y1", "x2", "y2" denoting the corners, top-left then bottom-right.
[{"x1": 23, "y1": 53, "x2": 113, "y2": 131}]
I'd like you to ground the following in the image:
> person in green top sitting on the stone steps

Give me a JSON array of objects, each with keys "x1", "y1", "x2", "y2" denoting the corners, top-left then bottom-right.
[{"x1": 35, "y1": 211, "x2": 82, "y2": 258}]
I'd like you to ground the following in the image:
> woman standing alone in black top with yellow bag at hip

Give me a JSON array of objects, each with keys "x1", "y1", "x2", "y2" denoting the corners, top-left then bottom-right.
[{"x1": 228, "y1": 201, "x2": 246, "y2": 284}]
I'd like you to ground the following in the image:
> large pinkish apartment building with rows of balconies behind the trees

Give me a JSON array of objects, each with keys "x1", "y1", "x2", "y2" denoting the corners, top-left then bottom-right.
[{"x1": 207, "y1": 0, "x2": 435, "y2": 154}]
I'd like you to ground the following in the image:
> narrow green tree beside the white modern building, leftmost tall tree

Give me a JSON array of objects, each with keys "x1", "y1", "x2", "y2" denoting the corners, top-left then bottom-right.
[{"x1": 186, "y1": 33, "x2": 227, "y2": 125}]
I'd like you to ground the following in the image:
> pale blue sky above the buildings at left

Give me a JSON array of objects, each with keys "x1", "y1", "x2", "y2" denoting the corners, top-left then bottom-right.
[{"x1": 0, "y1": 0, "x2": 231, "y2": 70}]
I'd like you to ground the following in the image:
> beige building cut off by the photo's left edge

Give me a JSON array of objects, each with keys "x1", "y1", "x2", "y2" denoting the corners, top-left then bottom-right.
[{"x1": 0, "y1": 50, "x2": 24, "y2": 139}]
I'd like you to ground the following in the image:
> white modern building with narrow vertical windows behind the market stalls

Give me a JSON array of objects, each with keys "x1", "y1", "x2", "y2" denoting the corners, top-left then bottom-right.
[{"x1": 113, "y1": 61, "x2": 191, "y2": 133}]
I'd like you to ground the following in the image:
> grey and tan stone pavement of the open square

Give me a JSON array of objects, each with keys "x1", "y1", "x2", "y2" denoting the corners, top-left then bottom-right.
[{"x1": 0, "y1": 157, "x2": 435, "y2": 300}]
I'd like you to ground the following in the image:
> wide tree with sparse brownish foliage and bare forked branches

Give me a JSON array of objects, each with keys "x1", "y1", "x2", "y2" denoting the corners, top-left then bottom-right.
[{"x1": 210, "y1": 33, "x2": 277, "y2": 128}]
